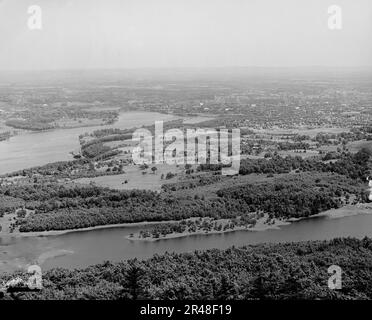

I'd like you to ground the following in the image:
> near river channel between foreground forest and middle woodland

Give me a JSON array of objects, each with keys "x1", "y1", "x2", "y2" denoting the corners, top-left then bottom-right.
[{"x1": 0, "y1": 211, "x2": 372, "y2": 271}]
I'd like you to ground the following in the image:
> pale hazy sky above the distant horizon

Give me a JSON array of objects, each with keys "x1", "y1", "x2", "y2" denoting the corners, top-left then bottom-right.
[{"x1": 0, "y1": 0, "x2": 372, "y2": 70}]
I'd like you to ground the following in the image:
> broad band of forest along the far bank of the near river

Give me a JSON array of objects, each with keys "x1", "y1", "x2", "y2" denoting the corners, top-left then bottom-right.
[{"x1": 0, "y1": 150, "x2": 370, "y2": 232}]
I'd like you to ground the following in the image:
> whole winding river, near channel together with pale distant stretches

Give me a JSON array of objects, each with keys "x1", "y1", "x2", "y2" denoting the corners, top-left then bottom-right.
[{"x1": 0, "y1": 112, "x2": 372, "y2": 272}]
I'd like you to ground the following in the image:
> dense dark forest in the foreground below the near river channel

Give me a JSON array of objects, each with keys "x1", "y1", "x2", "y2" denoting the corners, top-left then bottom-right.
[{"x1": 0, "y1": 238, "x2": 372, "y2": 300}]
